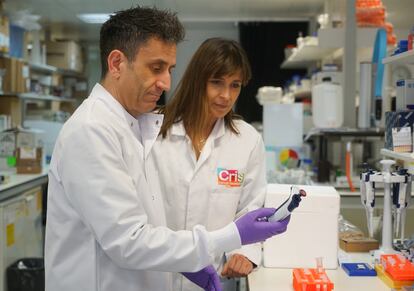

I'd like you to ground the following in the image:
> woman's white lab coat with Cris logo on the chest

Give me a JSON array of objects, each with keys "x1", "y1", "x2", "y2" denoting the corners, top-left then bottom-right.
[{"x1": 149, "y1": 119, "x2": 266, "y2": 291}]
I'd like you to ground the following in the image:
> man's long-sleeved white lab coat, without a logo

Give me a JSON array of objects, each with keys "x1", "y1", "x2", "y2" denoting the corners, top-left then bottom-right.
[{"x1": 45, "y1": 84, "x2": 241, "y2": 291}]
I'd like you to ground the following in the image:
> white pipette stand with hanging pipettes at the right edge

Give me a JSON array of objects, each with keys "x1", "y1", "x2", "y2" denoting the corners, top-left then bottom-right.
[{"x1": 360, "y1": 160, "x2": 411, "y2": 258}]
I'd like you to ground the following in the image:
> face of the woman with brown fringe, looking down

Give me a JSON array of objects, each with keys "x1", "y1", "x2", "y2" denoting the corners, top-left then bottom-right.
[{"x1": 207, "y1": 70, "x2": 242, "y2": 122}]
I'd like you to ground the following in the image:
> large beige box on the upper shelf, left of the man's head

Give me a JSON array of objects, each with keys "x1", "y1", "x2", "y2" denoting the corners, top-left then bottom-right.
[{"x1": 46, "y1": 41, "x2": 83, "y2": 72}]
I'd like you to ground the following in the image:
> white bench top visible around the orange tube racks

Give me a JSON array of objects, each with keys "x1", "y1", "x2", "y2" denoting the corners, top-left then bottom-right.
[{"x1": 247, "y1": 253, "x2": 390, "y2": 291}]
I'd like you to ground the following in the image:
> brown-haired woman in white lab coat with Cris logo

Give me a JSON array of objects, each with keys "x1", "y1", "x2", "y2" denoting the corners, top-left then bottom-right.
[{"x1": 150, "y1": 38, "x2": 266, "y2": 290}]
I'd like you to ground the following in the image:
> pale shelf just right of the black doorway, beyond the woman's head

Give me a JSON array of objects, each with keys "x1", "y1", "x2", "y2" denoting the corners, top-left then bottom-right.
[{"x1": 280, "y1": 45, "x2": 337, "y2": 69}]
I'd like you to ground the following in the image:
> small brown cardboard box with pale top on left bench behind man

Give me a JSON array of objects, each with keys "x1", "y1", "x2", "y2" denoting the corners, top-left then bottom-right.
[{"x1": 16, "y1": 147, "x2": 43, "y2": 174}]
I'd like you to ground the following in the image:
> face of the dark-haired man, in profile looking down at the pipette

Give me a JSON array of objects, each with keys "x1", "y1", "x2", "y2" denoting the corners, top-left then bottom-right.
[{"x1": 118, "y1": 38, "x2": 176, "y2": 116}]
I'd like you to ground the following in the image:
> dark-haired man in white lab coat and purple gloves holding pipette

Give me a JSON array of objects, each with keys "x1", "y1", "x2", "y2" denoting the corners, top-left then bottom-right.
[{"x1": 45, "y1": 7, "x2": 288, "y2": 291}]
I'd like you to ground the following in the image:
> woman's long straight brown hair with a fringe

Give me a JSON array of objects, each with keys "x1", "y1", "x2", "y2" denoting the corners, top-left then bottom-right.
[{"x1": 160, "y1": 38, "x2": 251, "y2": 138}]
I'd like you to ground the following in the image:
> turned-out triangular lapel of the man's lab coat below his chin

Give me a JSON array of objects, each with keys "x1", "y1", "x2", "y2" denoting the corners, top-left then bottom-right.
[{"x1": 138, "y1": 113, "x2": 164, "y2": 159}]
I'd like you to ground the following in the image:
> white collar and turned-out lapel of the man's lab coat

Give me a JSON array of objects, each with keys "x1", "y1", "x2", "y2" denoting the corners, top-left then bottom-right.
[{"x1": 91, "y1": 83, "x2": 164, "y2": 158}]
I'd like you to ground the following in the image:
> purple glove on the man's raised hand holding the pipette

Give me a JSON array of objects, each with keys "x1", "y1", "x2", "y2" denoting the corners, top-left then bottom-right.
[{"x1": 235, "y1": 208, "x2": 290, "y2": 245}]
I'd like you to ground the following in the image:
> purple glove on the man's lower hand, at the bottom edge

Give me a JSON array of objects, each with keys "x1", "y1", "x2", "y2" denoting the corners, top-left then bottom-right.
[{"x1": 181, "y1": 265, "x2": 223, "y2": 291}]
